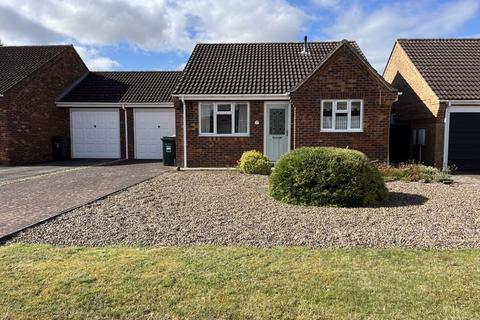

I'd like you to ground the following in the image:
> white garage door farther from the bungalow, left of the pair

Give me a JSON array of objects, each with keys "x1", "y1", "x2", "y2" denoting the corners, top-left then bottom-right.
[{"x1": 70, "y1": 109, "x2": 120, "y2": 159}]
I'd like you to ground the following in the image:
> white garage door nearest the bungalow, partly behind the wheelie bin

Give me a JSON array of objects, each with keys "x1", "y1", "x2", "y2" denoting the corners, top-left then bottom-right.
[{"x1": 134, "y1": 109, "x2": 175, "y2": 159}]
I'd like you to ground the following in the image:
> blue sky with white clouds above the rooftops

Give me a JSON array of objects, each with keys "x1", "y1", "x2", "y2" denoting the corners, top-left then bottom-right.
[{"x1": 0, "y1": 0, "x2": 480, "y2": 72}]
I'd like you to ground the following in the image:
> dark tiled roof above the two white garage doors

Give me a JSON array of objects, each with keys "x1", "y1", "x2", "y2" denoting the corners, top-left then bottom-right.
[{"x1": 59, "y1": 71, "x2": 182, "y2": 103}]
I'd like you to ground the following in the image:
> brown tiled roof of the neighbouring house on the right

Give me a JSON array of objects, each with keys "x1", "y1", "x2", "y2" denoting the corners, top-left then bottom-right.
[{"x1": 398, "y1": 39, "x2": 480, "y2": 100}]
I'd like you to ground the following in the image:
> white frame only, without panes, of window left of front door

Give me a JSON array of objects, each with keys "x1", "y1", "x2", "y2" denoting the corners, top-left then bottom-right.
[{"x1": 198, "y1": 101, "x2": 250, "y2": 137}]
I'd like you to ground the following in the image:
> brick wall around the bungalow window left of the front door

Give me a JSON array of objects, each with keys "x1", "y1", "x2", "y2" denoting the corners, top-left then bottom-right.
[{"x1": 174, "y1": 99, "x2": 264, "y2": 167}]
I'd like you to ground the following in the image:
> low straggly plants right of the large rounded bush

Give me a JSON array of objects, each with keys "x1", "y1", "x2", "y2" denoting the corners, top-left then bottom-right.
[{"x1": 377, "y1": 163, "x2": 450, "y2": 182}]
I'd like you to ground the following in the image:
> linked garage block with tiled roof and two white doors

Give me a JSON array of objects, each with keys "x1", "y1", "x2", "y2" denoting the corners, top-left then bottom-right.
[{"x1": 57, "y1": 71, "x2": 182, "y2": 159}]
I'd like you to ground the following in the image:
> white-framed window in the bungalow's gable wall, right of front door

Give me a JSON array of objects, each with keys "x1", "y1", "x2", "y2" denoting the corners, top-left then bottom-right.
[{"x1": 320, "y1": 99, "x2": 363, "y2": 132}]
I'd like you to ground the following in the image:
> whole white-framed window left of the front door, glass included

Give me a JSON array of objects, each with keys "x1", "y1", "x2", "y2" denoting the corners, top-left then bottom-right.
[{"x1": 198, "y1": 102, "x2": 250, "y2": 137}]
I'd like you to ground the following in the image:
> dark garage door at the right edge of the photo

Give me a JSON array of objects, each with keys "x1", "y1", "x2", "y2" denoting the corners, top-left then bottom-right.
[{"x1": 448, "y1": 112, "x2": 480, "y2": 171}]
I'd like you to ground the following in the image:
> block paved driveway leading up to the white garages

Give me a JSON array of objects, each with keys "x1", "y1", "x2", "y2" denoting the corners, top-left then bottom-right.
[{"x1": 0, "y1": 162, "x2": 172, "y2": 238}]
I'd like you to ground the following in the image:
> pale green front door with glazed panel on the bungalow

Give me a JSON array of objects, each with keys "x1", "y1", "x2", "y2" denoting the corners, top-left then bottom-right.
[{"x1": 264, "y1": 102, "x2": 290, "y2": 161}]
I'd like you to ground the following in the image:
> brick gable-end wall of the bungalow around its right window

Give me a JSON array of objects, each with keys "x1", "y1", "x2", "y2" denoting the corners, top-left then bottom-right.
[{"x1": 290, "y1": 47, "x2": 397, "y2": 161}]
